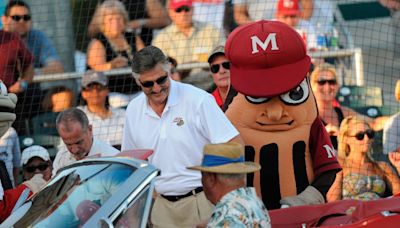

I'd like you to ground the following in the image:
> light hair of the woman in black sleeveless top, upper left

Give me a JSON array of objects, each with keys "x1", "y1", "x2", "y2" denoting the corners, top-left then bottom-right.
[{"x1": 90, "y1": 0, "x2": 129, "y2": 33}]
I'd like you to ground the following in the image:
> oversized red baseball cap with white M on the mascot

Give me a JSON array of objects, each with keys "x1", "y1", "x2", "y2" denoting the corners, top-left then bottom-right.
[{"x1": 225, "y1": 20, "x2": 311, "y2": 97}]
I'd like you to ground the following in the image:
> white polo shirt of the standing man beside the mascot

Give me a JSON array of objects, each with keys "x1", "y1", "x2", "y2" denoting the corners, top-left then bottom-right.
[{"x1": 121, "y1": 80, "x2": 239, "y2": 195}]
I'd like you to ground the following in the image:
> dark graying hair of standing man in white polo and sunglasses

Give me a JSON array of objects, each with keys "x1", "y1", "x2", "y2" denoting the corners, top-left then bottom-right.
[{"x1": 132, "y1": 46, "x2": 170, "y2": 79}]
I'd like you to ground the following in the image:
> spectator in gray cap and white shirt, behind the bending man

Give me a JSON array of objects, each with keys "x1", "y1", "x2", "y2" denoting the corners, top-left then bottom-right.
[{"x1": 78, "y1": 71, "x2": 125, "y2": 148}]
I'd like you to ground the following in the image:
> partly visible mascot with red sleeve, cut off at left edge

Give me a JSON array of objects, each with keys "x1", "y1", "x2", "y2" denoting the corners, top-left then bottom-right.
[{"x1": 0, "y1": 80, "x2": 46, "y2": 222}]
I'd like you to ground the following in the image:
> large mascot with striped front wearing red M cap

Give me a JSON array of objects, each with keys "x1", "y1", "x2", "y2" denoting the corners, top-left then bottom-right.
[{"x1": 225, "y1": 21, "x2": 341, "y2": 209}]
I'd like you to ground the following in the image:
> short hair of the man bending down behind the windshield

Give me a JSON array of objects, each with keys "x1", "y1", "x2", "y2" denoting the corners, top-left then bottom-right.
[{"x1": 56, "y1": 108, "x2": 89, "y2": 131}]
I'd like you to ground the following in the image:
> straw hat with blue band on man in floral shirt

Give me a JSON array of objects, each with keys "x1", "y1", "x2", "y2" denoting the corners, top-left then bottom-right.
[{"x1": 188, "y1": 142, "x2": 261, "y2": 174}]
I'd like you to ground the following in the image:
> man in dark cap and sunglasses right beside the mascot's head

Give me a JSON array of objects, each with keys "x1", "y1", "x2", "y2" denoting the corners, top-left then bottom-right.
[{"x1": 208, "y1": 45, "x2": 231, "y2": 108}]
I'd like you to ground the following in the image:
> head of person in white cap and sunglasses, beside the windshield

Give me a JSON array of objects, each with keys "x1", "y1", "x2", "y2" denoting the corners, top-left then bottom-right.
[{"x1": 21, "y1": 145, "x2": 53, "y2": 181}]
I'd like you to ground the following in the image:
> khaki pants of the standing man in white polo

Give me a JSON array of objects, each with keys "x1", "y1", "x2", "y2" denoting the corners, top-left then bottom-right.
[{"x1": 151, "y1": 192, "x2": 214, "y2": 228}]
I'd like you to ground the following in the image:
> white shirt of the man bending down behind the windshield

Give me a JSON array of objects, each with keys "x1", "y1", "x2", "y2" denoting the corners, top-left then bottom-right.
[{"x1": 53, "y1": 137, "x2": 119, "y2": 176}]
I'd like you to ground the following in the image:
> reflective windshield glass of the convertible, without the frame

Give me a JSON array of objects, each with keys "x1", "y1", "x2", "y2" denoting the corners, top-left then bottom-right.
[{"x1": 15, "y1": 163, "x2": 135, "y2": 227}]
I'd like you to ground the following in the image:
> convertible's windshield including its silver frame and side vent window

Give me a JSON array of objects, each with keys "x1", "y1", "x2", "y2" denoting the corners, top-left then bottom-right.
[{"x1": 0, "y1": 153, "x2": 159, "y2": 228}]
